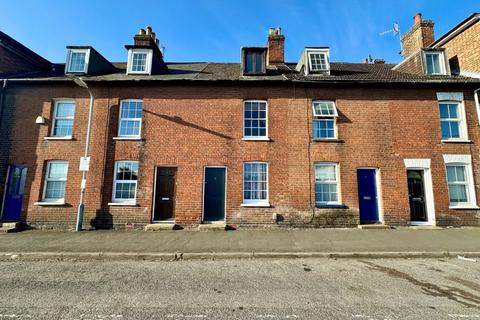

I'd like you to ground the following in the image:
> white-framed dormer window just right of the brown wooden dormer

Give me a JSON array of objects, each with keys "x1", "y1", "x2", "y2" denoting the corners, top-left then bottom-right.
[{"x1": 295, "y1": 47, "x2": 330, "y2": 75}]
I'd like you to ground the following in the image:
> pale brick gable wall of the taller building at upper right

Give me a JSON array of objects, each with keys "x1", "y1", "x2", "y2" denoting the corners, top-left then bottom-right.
[{"x1": 442, "y1": 22, "x2": 480, "y2": 73}]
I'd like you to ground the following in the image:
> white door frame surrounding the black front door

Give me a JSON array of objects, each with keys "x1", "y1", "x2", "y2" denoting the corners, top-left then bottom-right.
[{"x1": 403, "y1": 159, "x2": 436, "y2": 226}]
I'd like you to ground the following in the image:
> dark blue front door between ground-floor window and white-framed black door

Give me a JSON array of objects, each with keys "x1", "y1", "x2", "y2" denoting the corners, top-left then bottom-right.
[{"x1": 357, "y1": 169, "x2": 379, "y2": 224}]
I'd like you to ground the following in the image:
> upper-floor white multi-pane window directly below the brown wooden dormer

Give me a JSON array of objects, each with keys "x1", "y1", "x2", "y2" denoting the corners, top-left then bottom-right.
[{"x1": 243, "y1": 100, "x2": 268, "y2": 140}]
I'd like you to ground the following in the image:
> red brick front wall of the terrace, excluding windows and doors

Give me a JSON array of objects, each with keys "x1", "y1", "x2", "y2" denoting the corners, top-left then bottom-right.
[{"x1": 4, "y1": 84, "x2": 480, "y2": 228}]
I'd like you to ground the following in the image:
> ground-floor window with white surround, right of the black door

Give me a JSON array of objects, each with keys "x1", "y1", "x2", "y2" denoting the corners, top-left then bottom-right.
[{"x1": 443, "y1": 155, "x2": 477, "y2": 209}]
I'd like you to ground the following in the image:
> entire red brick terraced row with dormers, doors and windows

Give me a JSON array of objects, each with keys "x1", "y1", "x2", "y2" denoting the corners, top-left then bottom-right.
[{"x1": 1, "y1": 15, "x2": 480, "y2": 228}]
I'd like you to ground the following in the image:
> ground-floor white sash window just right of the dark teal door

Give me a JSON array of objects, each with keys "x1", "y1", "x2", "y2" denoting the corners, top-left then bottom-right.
[{"x1": 243, "y1": 162, "x2": 269, "y2": 206}]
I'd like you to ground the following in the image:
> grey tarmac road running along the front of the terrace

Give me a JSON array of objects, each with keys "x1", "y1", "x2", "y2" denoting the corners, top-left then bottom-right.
[{"x1": 0, "y1": 258, "x2": 480, "y2": 320}]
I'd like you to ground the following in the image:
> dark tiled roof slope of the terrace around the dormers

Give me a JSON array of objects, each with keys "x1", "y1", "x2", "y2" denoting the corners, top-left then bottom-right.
[{"x1": 3, "y1": 62, "x2": 480, "y2": 83}]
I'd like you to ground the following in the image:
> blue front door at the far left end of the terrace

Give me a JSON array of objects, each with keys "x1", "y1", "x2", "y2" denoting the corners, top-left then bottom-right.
[{"x1": 1, "y1": 165, "x2": 27, "y2": 221}]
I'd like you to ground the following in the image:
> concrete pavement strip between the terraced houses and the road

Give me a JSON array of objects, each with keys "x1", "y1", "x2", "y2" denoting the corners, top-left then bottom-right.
[{"x1": 0, "y1": 228, "x2": 480, "y2": 260}]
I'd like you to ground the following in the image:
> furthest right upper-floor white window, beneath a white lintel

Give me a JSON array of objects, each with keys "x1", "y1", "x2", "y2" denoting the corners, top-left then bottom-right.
[{"x1": 439, "y1": 101, "x2": 467, "y2": 140}]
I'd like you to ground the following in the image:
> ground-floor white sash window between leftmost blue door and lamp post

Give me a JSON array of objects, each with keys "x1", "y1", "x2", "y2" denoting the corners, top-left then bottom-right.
[{"x1": 42, "y1": 160, "x2": 68, "y2": 203}]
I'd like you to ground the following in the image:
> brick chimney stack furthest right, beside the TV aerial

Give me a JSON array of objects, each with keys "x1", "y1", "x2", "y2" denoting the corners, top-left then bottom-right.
[{"x1": 402, "y1": 13, "x2": 435, "y2": 58}]
